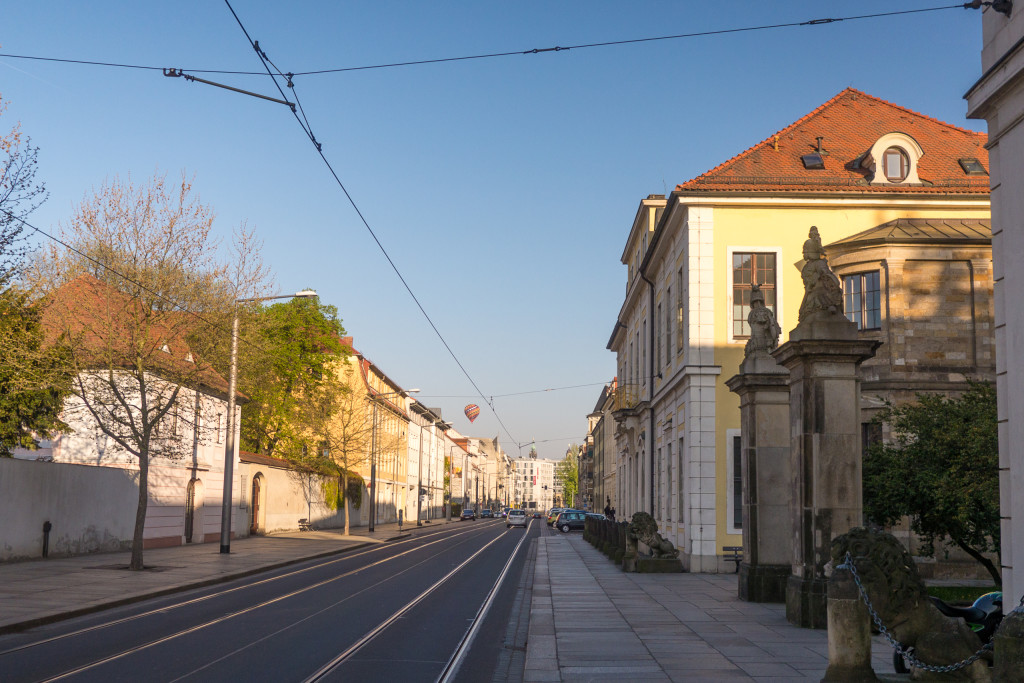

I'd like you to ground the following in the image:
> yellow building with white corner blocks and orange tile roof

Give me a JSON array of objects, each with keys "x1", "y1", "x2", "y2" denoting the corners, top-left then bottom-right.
[{"x1": 608, "y1": 88, "x2": 991, "y2": 571}]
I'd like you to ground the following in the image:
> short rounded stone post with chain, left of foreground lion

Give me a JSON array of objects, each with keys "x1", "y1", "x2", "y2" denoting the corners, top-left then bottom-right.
[{"x1": 821, "y1": 567, "x2": 878, "y2": 683}]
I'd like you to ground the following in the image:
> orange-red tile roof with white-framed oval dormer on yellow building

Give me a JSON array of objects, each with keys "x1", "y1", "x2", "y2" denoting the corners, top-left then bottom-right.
[{"x1": 676, "y1": 88, "x2": 989, "y2": 195}]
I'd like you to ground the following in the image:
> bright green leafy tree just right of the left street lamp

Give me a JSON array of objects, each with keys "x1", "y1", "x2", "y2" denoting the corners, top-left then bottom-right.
[{"x1": 239, "y1": 298, "x2": 348, "y2": 456}]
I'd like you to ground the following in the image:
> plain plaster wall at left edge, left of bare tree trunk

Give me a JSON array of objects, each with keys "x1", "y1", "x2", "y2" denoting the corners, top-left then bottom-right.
[{"x1": 0, "y1": 458, "x2": 138, "y2": 561}]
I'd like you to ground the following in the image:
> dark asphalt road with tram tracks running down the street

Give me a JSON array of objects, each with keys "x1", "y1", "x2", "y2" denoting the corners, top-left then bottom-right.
[{"x1": 0, "y1": 519, "x2": 540, "y2": 683}]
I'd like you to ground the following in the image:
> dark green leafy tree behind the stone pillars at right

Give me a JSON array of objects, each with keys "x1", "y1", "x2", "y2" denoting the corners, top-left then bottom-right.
[{"x1": 864, "y1": 383, "x2": 1001, "y2": 584}]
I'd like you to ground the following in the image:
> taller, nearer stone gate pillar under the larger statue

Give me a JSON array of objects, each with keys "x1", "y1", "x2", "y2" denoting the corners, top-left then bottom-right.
[{"x1": 773, "y1": 337, "x2": 881, "y2": 629}]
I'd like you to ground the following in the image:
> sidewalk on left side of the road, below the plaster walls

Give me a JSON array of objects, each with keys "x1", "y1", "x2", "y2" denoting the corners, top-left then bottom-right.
[{"x1": 0, "y1": 520, "x2": 436, "y2": 634}]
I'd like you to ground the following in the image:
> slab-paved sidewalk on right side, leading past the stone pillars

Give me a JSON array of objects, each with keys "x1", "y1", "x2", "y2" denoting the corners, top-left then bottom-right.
[{"x1": 523, "y1": 529, "x2": 892, "y2": 683}]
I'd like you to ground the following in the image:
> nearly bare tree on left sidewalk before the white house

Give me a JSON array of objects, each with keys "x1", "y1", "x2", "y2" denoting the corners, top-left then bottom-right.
[{"x1": 28, "y1": 176, "x2": 266, "y2": 569}]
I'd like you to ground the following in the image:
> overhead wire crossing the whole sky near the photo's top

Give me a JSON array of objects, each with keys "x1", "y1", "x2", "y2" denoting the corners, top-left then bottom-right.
[{"x1": 0, "y1": 2, "x2": 980, "y2": 76}]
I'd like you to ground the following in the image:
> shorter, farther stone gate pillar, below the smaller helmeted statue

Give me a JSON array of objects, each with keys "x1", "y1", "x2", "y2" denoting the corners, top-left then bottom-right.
[{"x1": 726, "y1": 355, "x2": 793, "y2": 602}]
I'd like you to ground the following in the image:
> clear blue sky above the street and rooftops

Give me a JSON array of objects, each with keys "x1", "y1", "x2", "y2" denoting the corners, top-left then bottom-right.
[{"x1": 0, "y1": 0, "x2": 984, "y2": 459}]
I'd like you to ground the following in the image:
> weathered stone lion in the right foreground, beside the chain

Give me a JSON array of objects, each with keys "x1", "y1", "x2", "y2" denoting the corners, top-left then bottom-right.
[{"x1": 829, "y1": 527, "x2": 991, "y2": 681}]
